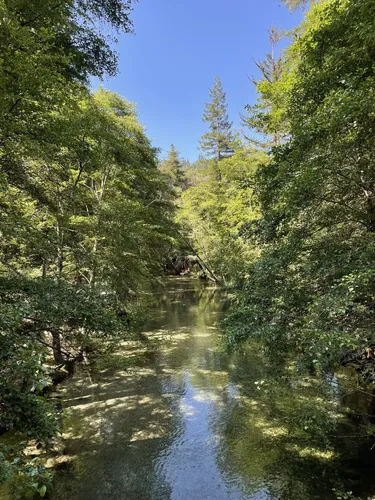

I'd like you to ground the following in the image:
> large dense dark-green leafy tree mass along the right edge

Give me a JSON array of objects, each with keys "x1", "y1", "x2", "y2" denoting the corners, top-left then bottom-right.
[{"x1": 223, "y1": 0, "x2": 375, "y2": 378}]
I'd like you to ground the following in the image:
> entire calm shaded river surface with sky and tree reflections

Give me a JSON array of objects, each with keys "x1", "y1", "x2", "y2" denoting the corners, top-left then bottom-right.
[{"x1": 51, "y1": 279, "x2": 375, "y2": 500}]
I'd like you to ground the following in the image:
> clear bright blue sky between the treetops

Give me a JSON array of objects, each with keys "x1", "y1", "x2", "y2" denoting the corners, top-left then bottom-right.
[{"x1": 93, "y1": 0, "x2": 302, "y2": 161}]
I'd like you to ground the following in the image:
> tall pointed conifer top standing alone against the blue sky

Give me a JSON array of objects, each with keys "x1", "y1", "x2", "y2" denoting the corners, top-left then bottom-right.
[{"x1": 200, "y1": 77, "x2": 233, "y2": 167}]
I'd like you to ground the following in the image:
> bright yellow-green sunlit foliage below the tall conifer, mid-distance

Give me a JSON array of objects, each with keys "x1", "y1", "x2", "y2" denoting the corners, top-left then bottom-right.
[{"x1": 178, "y1": 148, "x2": 267, "y2": 282}]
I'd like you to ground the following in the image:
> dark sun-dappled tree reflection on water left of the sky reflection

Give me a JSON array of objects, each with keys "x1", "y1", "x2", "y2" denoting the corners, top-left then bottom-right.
[{"x1": 52, "y1": 360, "x2": 180, "y2": 500}]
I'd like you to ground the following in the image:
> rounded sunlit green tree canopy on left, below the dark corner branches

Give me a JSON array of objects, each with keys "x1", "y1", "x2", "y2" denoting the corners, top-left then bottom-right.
[{"x1": 0, "y1": 84, "x2": 176, "y2": 292}]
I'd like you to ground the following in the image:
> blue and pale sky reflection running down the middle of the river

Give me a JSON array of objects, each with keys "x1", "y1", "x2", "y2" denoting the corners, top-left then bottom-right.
[{"x1": 153, "y1": 290, "x2": 269, "y2": 500}]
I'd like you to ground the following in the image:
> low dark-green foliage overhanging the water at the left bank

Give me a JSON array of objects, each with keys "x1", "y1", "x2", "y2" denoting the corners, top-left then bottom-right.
[{"x1": 0, "y1": 278, "x2": 132, "y2": 442}]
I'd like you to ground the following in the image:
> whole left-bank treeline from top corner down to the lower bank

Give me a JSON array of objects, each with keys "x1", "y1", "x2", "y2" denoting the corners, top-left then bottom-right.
[{"x1": 0, "y1": 0, "x2": 174, "y2": 492}]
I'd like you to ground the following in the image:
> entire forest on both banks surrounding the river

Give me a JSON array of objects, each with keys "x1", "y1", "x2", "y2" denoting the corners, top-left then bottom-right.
[{"x1": 0, "y1": 0, "x2": 375, "y2": 498}]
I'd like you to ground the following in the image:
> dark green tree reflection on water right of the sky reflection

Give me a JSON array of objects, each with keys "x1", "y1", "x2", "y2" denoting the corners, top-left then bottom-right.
[{"x1": 218, "y1": 351, "x2": 374, "y2": 500}]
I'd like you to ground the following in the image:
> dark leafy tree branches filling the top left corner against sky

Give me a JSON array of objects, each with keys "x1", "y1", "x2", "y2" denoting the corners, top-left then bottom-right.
[{"x1": 0, "y1": 0, "x2": 138, "y2": 213}]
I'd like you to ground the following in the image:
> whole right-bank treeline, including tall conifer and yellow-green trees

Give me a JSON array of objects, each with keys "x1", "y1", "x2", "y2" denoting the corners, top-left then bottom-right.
[{"x1": 179, "y1": 0, "x2": 375, "y2": 380}]
